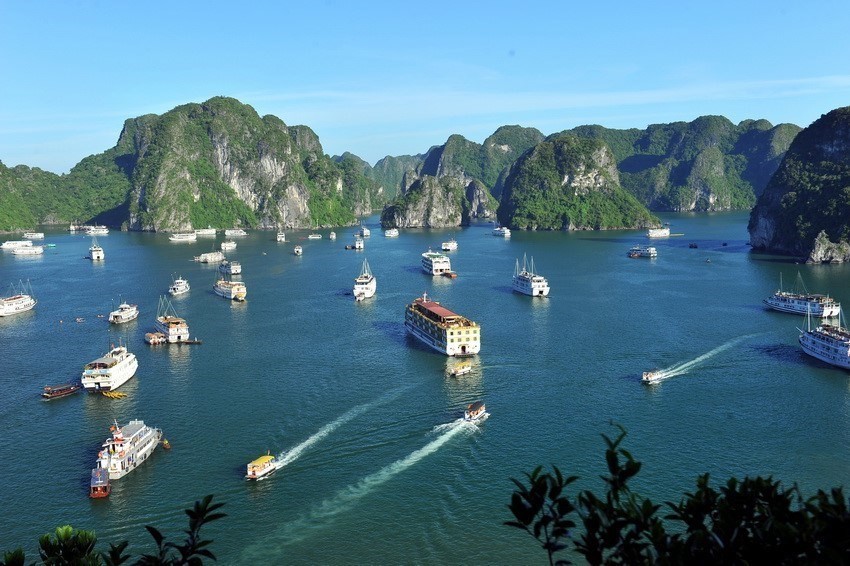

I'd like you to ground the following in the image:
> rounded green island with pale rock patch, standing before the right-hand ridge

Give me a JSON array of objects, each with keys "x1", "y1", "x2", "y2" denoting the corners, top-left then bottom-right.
[{"x1": 498, "y1": 135, "x2": 660, "y2": 230}]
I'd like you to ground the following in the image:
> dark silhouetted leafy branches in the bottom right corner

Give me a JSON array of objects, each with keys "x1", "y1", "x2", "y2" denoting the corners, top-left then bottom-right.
[{"x1": 505, "y1": 427, "x2": 850, "y2": 565}]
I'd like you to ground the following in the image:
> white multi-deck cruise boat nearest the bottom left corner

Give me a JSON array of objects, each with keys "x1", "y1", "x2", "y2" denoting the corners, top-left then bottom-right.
[{"x1": 92, "y1": 420, "x2": 162, "y2": 484}]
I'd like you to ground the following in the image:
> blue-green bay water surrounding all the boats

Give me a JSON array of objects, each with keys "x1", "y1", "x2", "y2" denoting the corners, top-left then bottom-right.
[{"x1": 0, "y1": 213, "x2": 850, "y2": 564}]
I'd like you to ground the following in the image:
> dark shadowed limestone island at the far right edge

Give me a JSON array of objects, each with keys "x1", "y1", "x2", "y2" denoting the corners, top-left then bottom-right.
[{"x1": 748, "y1": 107, "x2": 850, "y2": 262}]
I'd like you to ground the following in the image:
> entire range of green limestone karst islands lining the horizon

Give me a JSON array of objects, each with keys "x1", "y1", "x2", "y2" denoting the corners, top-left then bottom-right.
[{"x1": 0, "y1": 97, "x2": 850, "y2": 261}]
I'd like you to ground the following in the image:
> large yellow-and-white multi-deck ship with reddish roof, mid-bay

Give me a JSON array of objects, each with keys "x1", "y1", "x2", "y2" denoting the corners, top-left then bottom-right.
[{"x1": 404, "y1": 294, "x2": 481, "y2": 356}]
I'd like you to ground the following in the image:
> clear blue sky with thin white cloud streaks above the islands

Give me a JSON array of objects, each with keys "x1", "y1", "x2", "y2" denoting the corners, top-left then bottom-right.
[{"x1": 0, "y1": 0, "x2": 850, "y2": 173}]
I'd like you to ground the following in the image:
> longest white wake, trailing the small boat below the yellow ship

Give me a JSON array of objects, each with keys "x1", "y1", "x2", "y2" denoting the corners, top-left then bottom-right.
[{"x1": 243, "y1": 419, "x2": 470, "y2": 559}]
